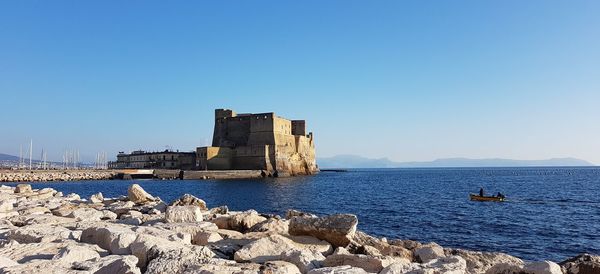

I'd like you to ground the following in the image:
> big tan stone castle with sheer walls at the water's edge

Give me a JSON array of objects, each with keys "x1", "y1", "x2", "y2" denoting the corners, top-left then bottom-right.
[{"x1": 196, "y1": 109, "x2": 318, "y2": 177}]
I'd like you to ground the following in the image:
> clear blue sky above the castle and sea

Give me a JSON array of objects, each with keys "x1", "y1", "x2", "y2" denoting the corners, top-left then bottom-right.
[{"x1": 0, "y1": 0, "x2": 600, "y2": 164}]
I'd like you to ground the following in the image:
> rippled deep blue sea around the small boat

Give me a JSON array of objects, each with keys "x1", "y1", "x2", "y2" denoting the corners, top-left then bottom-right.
[{"x1": 5, "y1": 167, "x2": 600, "y2": 261}]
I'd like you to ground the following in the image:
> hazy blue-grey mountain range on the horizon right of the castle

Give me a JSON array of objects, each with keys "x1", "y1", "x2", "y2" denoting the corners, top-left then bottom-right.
[{"x1": 317, "y1": 155, "x2": 594, "y2": 168}]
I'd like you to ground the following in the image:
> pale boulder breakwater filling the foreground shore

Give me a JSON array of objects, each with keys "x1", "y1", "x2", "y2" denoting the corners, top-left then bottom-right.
[{"x1": 0, "y1": 184, "x2": 600, "y2": 274}]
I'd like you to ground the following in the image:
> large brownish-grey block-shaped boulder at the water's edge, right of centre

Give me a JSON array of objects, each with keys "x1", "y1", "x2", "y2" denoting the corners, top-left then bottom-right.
[{"x1": 289, "y1": 214, "x2": 358, "y2": 246}]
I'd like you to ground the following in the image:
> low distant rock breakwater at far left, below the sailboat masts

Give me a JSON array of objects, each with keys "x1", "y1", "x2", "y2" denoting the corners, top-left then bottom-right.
[{"x1": 0, "y1": 170, "x2": 117, "y2": 182}]
